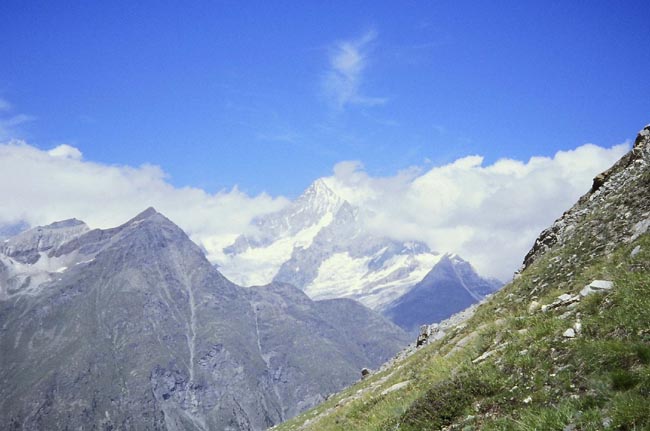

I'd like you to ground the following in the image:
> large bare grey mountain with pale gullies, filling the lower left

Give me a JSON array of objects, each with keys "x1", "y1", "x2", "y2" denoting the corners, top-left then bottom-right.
[{"x1": 0, "y1": 209, "x2": 407, "y2": 430}]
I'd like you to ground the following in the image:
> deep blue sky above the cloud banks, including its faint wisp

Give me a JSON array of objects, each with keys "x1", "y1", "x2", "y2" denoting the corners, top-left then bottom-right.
[{"x1": 0, "y1": 0, "x2": 650, "y2": 197}]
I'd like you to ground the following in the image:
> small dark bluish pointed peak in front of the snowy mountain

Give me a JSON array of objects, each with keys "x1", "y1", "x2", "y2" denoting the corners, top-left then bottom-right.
[{"x1": 384, "y1": 255, "x2": 503, "y2": 332}]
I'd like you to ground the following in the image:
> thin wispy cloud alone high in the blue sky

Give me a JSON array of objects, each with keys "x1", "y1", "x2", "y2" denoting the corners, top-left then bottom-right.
[{"x1": 322, "y1": 31, "x2": 386, "y2": 109}]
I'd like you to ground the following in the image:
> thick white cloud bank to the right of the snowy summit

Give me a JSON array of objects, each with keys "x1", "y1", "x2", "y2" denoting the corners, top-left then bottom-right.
[{"x1": 326, "y1": 143, "x2": 629, "y2": 280}]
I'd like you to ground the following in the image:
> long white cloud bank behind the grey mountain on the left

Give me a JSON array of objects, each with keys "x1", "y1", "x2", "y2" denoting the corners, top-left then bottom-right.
[{"x1": 0, "y1": 141, "x2": 286, "y2": 258}]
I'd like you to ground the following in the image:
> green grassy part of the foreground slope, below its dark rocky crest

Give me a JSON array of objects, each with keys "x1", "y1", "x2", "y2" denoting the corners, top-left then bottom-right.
[{"x1": 277, "y1": 235, "x2": 650, "y2": 430}]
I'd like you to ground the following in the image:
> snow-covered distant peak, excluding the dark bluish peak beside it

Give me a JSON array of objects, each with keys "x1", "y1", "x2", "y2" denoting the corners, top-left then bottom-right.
[{"x1": 217, "y1": 179, "x2": 454, "y2": 309}]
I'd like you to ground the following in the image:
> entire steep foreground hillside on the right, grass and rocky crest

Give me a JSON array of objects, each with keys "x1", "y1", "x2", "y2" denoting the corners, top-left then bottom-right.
[{"x1": 270, "y1": 126, "x2": 650, "y2": 431}]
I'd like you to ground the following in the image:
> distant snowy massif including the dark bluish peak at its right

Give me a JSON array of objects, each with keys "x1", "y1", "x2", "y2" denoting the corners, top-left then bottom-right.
[{"x1": 219, "y1": 178, "x2": 503, "y2": 331}]
